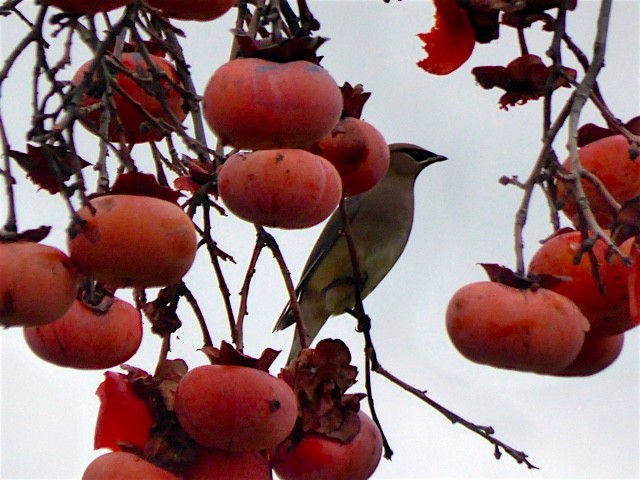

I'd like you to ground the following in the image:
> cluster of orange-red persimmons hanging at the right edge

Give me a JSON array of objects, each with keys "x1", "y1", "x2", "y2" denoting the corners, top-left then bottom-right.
[{"x1": 447, "y1": 130, "x2": 640, "y2": 376}]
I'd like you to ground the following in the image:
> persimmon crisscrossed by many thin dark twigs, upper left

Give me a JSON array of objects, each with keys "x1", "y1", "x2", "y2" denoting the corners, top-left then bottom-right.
[{"x1": 71, "y1": 52, "x2": 187, "y2": 143}]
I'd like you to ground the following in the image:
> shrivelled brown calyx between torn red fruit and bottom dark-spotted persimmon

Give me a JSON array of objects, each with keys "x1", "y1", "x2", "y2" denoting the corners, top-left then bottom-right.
[{"x1": 122, "y1": 359, "x2": 196, "y2": 472}]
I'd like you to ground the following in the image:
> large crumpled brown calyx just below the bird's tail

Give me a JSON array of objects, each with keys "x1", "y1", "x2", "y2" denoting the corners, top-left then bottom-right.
[{"x1": 279, "y1": 339, "x2": 365, "y2": 443}]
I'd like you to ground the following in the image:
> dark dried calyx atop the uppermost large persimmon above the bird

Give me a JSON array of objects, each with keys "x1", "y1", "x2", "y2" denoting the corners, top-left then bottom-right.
[{"x1": 233, "y1": 30, "x2": 328, "y2": 64}]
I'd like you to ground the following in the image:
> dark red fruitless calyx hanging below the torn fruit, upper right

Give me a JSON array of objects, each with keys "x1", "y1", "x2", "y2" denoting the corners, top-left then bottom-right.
[{"x1": 471, "y1": 54, "x2": 577, "y2": 109}]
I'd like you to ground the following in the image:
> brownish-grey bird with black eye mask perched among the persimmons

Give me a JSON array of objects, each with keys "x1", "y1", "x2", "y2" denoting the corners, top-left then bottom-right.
[{"x1": 274, "y1": 143, "x2": 446, "y2": 362}]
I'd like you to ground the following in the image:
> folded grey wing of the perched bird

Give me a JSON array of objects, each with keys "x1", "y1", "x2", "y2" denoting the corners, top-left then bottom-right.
[{"x1": 273, "y1": 195, "x2": 362, "y2": 332}]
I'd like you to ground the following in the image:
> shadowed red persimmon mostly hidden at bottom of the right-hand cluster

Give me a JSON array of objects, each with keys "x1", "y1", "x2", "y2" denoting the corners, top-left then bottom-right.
[{"x1": 556, "y1": 333, "x2": 624, "y2": 377}]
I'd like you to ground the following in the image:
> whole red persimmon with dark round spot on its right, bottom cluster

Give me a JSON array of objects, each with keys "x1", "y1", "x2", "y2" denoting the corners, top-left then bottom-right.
[{"x1": 175, "y1": 365, "x2": 298, "y2": 452}]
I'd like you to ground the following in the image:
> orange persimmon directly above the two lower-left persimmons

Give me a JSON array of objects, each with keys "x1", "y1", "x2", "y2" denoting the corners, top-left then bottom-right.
[{"x1": 68, "y1": 195, "x2": 197, "y2": 288}]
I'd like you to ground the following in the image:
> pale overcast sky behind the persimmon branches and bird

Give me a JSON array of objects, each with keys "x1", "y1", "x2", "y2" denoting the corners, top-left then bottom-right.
[{"x1": 0, "y1": 0, "x2": 640, "y2": 479}]
